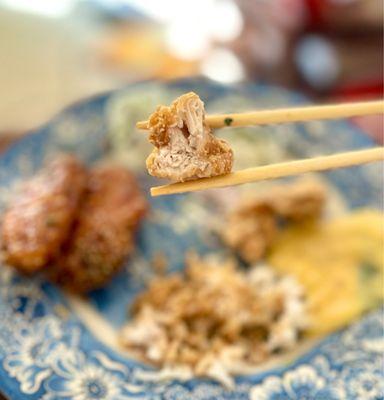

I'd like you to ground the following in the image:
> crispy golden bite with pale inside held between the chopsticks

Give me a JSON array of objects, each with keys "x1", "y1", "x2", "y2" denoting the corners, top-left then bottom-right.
[{"x1": 146, "y1": 92, "x2": 233, "y2": 182}]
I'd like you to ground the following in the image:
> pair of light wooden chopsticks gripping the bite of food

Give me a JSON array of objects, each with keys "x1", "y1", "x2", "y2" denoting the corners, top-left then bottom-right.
[{"x1": 142, "y1": 100, "x2": 384, "y2": 196}]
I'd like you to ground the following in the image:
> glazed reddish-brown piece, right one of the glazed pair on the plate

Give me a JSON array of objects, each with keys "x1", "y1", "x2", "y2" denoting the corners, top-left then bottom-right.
[{"x1": 51, "y1": 166, "x2": 147, "y2": 293}]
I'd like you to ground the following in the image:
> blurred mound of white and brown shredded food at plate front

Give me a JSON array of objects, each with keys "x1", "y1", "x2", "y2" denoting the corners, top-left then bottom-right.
[{"x1": 121, "y1": 255, "x2": 307, "y2": 386}]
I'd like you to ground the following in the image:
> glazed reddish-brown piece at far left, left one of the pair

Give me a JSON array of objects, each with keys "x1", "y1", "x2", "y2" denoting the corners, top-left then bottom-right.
[{"x1": 0, "y1": 156, "x2": 86, "y2": 273}]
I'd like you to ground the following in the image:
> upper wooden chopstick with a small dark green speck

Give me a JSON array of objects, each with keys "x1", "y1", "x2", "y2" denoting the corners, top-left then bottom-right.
[{"x1": 136, "y1": 100, "x2": 384, "y2": 129}]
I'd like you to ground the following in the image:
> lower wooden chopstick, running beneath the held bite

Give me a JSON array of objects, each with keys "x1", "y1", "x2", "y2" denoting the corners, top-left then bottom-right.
[{"x1": 151, "y1": 147, "x2": 384, "y2": 196}]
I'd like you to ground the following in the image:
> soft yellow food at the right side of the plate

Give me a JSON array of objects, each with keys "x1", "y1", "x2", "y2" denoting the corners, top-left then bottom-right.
[{"x1": 268, "y1": 210, "x2": 384, "y2": 336}]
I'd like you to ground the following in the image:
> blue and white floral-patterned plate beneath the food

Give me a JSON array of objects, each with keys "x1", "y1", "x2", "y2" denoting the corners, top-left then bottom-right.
[{"x1": 0, "y1": 80, "x2": 384, "y2": 400}]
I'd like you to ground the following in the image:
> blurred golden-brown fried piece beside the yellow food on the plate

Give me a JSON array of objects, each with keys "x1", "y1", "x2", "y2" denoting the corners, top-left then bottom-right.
[{"x1": 219, "y1": 179, "x2": 326, "y2": 263}]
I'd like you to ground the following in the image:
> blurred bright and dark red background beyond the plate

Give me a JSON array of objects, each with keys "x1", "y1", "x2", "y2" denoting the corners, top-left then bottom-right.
[{"x1": 0, "y1": 0, "x2": 383, "y2": 148}]
